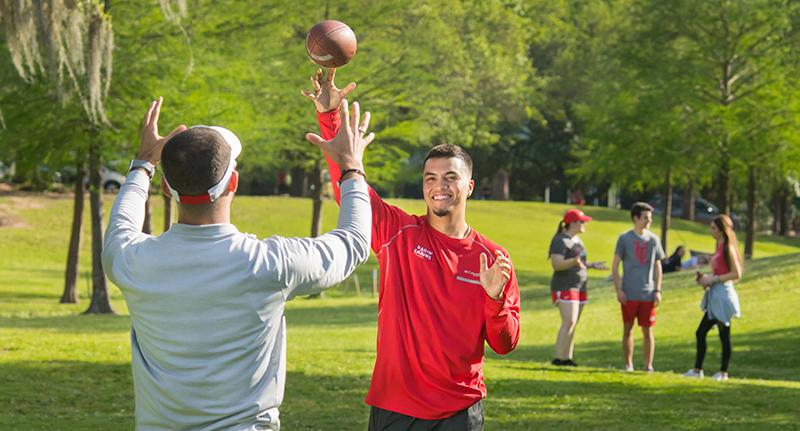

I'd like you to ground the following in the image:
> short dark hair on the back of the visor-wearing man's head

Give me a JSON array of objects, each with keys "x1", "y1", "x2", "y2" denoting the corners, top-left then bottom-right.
[{"x1": 161, "y1": 127, "x2": 231, "y2": 196}]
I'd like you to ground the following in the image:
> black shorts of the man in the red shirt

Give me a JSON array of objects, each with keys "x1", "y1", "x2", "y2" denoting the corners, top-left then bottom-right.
[{"x1": 369, "y1": 401, "x2": 483, "y2": 431}]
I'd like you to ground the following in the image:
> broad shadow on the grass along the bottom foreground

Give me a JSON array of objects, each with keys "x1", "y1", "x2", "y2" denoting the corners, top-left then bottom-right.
[{"x1": 0, "y1": 361, "x2": 800, "y2": 431}]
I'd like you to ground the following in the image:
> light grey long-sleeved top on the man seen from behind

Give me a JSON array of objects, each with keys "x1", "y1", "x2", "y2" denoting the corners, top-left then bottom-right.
[{"x1": 103, "y1": 170, "x2": 372, "y2": 430}]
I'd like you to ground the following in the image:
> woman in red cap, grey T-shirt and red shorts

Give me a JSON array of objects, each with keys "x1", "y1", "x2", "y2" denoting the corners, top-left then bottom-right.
[{"x1": 549, "y1": 209, "x2": 608, "y2": 367}]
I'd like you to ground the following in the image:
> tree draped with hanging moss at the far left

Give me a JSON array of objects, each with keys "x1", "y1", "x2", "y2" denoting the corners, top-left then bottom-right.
[{"x1": 0, "y1": 0, "x2": 113, "y2": 313}]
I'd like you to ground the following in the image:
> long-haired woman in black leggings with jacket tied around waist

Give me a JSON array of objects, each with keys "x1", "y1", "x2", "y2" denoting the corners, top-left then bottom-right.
[{"x1": 684, "y1": 214, "x2": 744, "y2": 382}]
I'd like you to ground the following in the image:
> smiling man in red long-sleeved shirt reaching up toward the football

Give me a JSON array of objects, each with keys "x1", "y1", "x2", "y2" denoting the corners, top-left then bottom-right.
[{"x1": 303, "y1": 69, "x2": 520, "y2": 431}]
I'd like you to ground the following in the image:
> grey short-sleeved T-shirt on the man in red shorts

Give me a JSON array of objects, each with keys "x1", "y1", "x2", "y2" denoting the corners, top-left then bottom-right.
[{"x1": 614, "y1": 230, "x2": 666, "y2": 301}]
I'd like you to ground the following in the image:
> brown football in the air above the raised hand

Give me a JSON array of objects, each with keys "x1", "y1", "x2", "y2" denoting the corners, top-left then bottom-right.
[{"x1": 306, "y1": 20, "x2": 358, "y2": 67}]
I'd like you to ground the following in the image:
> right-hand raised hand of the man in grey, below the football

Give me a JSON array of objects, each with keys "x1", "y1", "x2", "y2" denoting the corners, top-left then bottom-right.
[{"x1": 306, "y1": 99, "x2": 375, "y2": 172}]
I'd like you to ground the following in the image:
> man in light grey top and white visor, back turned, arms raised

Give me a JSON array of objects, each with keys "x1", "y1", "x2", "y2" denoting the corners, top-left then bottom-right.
[{"x1": 103, "y1": 99, "x2": 374, "y2": 430}]
